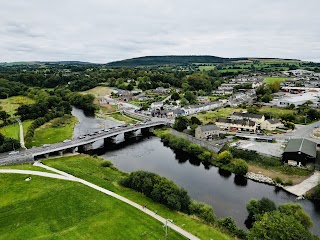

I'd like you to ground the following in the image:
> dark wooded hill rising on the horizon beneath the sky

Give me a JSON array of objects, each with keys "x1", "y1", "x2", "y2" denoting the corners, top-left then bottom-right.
[{"x1": 107, "y1": 56, "x2": 248, "y2": 67}]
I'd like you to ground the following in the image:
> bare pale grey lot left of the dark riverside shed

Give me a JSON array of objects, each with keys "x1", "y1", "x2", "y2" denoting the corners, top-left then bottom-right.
[{"x1": 234, "y1": 140, "x2": 285, "y2": 157}]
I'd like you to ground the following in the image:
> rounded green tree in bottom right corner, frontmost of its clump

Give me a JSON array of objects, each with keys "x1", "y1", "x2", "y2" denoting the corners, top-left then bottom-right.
[{"x1": 248, "y1": 211, "x2": 314, "y2": 240}]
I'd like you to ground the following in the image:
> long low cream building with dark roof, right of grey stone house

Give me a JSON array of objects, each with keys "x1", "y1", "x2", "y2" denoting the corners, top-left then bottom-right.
[{"x1": 215, "y1": 118, "x2": 257, "y2": 132}]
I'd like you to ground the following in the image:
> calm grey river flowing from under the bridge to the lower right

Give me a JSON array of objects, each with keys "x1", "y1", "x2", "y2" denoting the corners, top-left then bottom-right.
[{"x1": 73, "y1": 108, "x2": 320, "y2": 236}]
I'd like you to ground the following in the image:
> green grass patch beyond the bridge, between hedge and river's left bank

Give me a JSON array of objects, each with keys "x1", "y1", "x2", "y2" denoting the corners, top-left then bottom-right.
[{"x1": 32, "y1": 115, "x2": 78, "y2": 147}]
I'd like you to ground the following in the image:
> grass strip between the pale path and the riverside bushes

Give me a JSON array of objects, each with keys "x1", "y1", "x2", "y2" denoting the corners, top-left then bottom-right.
[{"x1": 43, "y1": 155, "x2": 232, "y2": 240}]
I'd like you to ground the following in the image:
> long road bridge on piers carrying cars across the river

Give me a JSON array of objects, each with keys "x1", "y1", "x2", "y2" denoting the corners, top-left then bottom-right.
[{"x1": 0, "y1": 121, "x2": 167, "y2": 166}]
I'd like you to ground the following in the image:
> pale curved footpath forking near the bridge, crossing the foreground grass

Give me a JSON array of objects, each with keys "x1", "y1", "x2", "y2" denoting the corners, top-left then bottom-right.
[{"x1": 0, "y1": 162, "x2": 200, "y2": 240}]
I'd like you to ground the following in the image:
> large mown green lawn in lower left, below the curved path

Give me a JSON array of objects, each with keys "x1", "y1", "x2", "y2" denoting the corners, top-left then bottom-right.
[{"x1": 0, "y1": 174, "x2": 184, "y2": 240}]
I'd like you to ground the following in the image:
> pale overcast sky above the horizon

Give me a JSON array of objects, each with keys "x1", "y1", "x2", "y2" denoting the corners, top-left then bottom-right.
[{"x1": 0, "y1": 0, "x2": 320, "y2": 63}]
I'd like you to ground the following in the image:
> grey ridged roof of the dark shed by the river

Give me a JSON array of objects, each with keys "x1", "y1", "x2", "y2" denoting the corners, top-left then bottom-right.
[{"x1": 284, "y1": 138, "x2": 317, "y2": 158}]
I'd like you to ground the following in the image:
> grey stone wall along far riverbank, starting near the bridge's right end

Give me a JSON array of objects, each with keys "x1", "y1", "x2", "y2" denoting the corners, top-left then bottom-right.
[{"x1": 170, "y1": 128, "x2": 227, "y2": 153}]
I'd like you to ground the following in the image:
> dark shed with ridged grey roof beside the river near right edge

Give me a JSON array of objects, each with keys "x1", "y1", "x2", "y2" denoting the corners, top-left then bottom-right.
[{"x1": 282, "y1": 138, "x2": 317, "y2": 166}]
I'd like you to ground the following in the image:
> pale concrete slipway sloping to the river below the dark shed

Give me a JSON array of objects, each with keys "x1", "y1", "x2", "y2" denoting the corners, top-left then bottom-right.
[{"x1": 284, "y1": 171, "x2": 320, "y2": 196}]
